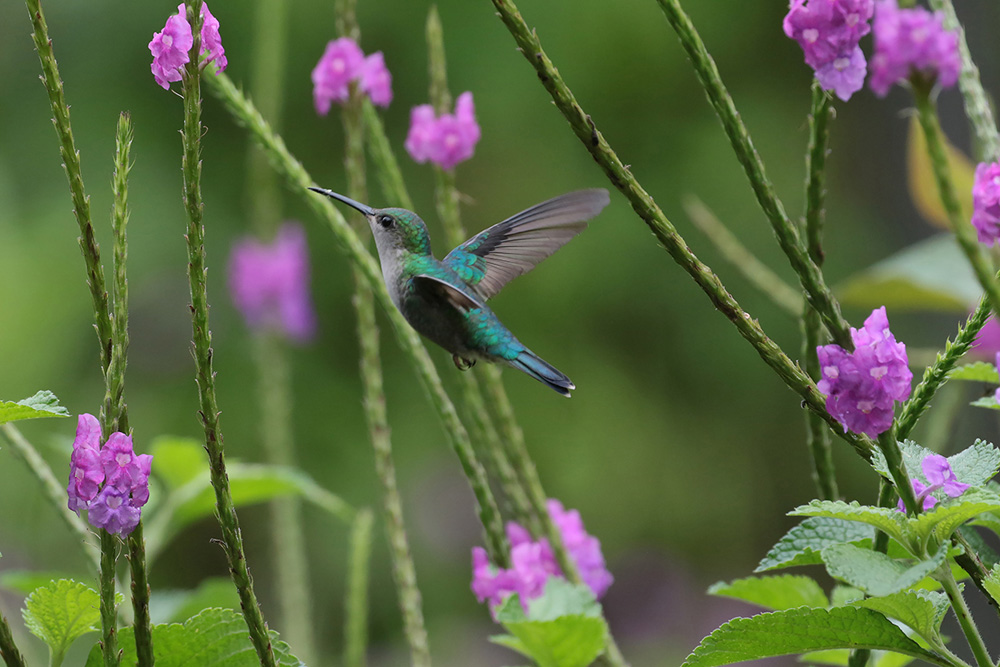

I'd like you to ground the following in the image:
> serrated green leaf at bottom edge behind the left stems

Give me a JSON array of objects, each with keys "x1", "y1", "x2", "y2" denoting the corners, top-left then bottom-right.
[{"x1": 86, "y1": 609, "x2": 303, "y2": 667}]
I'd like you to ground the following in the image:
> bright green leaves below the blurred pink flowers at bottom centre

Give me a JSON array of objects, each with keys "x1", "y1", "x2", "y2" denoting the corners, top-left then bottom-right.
[{"x1": 490, "y1": 577, "x2": 608, "y2": 667}]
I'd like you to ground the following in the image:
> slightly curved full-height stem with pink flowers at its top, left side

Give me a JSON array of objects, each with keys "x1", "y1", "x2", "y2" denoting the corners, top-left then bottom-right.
[{"x1": 182, "y1": 0, "x2": 275, "y2": 667}]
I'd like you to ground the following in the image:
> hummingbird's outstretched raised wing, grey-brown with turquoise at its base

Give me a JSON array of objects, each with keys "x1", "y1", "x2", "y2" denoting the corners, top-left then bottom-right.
[{"x1": 444, "y1": 188, "x2": 609, "y2": 299}]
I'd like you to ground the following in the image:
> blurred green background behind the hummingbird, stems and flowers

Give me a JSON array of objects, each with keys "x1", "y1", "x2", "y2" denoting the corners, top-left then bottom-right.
[{"x1": 0, "y1": 0, "x2": 1000, "y2": 667}]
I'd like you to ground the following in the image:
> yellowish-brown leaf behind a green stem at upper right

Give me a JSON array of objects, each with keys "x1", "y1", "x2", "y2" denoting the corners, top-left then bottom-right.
[{"x1": 906, "y1": 116, "x2": 975, "y2": 234}]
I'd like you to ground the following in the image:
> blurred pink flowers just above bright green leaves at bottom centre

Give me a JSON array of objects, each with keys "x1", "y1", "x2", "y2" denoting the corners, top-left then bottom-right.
[{"x1": 472, "y1": 500, "x2": 614, "y2": 612}]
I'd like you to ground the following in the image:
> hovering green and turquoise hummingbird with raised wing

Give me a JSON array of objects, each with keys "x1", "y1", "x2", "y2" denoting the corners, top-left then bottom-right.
[{"x1": 309, "y1": 188, "x2": 609, "y2": 396}]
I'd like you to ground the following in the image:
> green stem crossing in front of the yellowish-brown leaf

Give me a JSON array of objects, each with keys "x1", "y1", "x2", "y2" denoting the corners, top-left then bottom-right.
[{"x1": 913, "y1": 87, "x2": 1000, "y2": 317}]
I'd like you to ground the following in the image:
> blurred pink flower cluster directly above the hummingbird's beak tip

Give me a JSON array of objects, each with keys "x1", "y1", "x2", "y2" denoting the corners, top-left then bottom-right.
[{"x1": 312, "y1": 37, "x2": 392, "y2": 116}]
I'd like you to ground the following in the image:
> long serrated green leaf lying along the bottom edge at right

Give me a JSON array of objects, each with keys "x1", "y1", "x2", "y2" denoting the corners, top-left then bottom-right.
[{"x1": 684, "y1": 607, "x2": 947, "y2": 667}]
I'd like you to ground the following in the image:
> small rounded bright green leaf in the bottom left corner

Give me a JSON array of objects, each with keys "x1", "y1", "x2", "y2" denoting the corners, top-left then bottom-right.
[{"x1": 21, "y1": 579, "x2": 101, "y2": 664}]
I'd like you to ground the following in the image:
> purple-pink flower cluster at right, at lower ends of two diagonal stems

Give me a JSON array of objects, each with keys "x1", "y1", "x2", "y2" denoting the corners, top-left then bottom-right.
[{"x1": 816, "y1": 306, "x2": 913, "y2": 438}]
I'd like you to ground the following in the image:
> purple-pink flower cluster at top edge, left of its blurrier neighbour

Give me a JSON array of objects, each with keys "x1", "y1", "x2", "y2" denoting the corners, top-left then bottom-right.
[{"x1": 783, "y1": 0, "x2": 875, "y2": 102}]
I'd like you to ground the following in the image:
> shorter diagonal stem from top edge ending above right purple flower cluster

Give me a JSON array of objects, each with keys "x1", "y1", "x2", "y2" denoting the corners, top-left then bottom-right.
[{"x1": 657, "y1": 0, "x2": 854, "y2": 350}]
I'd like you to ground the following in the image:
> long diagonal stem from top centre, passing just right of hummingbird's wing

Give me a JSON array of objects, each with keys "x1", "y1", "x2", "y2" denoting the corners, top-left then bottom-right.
[{"x1": 484, "y1": 0, "x2": 874, "y2": 461}]
